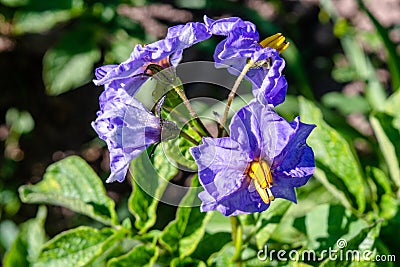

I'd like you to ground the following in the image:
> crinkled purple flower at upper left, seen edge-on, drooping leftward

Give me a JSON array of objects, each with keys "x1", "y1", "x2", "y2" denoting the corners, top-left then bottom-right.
[{"x1": 93, "y1": 22, "x2": 211, "y2": 99}]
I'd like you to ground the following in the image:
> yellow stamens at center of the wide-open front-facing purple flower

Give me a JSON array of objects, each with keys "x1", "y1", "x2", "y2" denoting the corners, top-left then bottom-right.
[{"x1": 247, "y1": 160, "x2": 275, "y2": 204}]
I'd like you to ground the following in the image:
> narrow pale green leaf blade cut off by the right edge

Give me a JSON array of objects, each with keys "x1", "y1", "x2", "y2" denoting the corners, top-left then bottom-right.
[{"x1": 370, "y1": 115, "x2": 400, "y2": 188}]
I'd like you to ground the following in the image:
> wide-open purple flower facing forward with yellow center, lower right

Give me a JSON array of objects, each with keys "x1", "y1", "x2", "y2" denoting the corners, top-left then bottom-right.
[{"x1": 191, "y1": 100, "x2": 315, "y2": 216}]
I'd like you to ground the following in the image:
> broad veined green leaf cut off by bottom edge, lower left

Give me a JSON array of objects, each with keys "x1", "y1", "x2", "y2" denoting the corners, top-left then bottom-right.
[{"x1": 33, "y1": 226, "x2": 119, "y2": 267}]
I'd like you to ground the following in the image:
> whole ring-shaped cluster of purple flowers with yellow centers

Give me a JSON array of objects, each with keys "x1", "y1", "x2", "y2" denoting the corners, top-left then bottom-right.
[{"x1": 92, "y1": 17, "x2": 315, "y2": 216}]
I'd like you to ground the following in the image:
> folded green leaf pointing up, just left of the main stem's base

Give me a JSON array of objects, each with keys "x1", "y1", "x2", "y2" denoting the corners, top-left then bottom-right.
[{"x1": 159, "y1": 176, "x2": 212, "y2": 258}]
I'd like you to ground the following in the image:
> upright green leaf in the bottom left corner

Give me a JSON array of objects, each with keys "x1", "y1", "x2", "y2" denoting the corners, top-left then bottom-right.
[{"x1": 3, "y1": 206, "x2": 47, "y2": 267}]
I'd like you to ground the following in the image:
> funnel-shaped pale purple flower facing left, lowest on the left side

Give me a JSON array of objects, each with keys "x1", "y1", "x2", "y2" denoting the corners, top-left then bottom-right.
[{"x1": 92, "y1": 88, "x2": 177, "y2": 183}]
